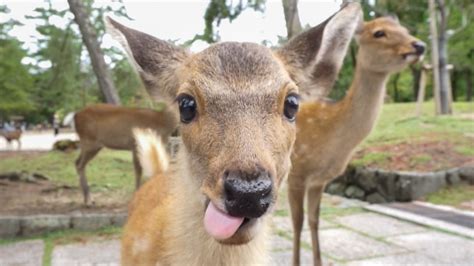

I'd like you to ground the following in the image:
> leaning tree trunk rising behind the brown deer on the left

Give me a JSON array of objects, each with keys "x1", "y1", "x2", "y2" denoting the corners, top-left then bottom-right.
[{"x1": 68, "y1": 0, "x2": 120, "y2": 105}]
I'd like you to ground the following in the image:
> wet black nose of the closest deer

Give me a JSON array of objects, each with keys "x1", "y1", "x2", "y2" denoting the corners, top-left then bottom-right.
[{"x1": 224, "y1": 171, "x2": 273, "y2": 218}]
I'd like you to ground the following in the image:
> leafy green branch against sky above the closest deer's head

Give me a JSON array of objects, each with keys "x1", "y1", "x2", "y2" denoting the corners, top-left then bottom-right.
[{"x1": 186, "y1": 0, "x2": 265, "y2": 45}]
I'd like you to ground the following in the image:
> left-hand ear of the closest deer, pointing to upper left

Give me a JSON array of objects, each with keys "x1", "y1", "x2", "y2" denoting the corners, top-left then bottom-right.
[{"x1": 106, "y1": 17, "x2": 189, "y2": 101}]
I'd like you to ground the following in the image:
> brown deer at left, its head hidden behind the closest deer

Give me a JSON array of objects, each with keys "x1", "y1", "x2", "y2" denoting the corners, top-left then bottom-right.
[{"x1": 74, "y1": 104, "x2": 178, "y2": 205}]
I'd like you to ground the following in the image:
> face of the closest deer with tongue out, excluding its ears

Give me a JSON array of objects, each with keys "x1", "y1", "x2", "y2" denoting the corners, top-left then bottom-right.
[{"x1": 176, "y1": 43, "x2": 298, "y2": 243}]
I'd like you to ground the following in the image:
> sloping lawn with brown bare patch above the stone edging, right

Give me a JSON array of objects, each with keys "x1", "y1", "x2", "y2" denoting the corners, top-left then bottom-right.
[{"x1": 352, "y1": 102, "x2": 474, "y2": 171}]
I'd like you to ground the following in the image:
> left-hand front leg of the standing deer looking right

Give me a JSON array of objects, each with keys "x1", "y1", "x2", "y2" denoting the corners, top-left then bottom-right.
[{"x1": 288, "y1": 184, "x2": 305, "y2": 265}]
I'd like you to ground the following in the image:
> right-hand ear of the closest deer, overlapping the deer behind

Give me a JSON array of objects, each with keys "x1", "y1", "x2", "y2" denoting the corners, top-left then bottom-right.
[{"x1": 277, "y1": 3, "x2": 363, "y2": 97}]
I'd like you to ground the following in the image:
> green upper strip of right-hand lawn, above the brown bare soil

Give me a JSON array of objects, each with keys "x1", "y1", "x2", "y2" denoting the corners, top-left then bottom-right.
[{"x1": 362, "y1": 102, "x2": 474, "y2": 147}]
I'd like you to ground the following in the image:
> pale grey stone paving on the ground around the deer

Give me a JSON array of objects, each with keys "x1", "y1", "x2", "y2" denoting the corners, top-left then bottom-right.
[{"x1": 0, "y1": 195, "x2": 474, "y2": 266}]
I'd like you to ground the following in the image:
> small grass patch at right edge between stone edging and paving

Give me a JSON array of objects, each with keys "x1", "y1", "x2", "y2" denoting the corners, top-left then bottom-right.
[{"x1": 425, "y1": 185, "x2": 474, "y2": 207}]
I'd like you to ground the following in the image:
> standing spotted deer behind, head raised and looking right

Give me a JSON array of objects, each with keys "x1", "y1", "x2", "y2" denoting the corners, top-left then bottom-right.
[{"x1": 288, "y1": 18, "x2": 425, "y2": 265}]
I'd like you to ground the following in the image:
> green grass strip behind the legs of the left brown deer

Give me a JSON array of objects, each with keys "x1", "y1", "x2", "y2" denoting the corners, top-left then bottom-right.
[{"x1": 0, "y1": 149, "x2": 135, "y2": 192}]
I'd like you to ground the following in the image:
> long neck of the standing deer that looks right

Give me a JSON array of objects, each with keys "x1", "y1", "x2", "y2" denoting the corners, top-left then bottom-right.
[{"x1": 339, "y1": 58, "x2": 389, "y2": 145}]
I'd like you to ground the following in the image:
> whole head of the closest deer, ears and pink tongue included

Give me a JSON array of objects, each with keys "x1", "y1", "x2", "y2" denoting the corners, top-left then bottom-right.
[{"x1": 109, "y1": 4, "x2": 360, "y2": 244}]
